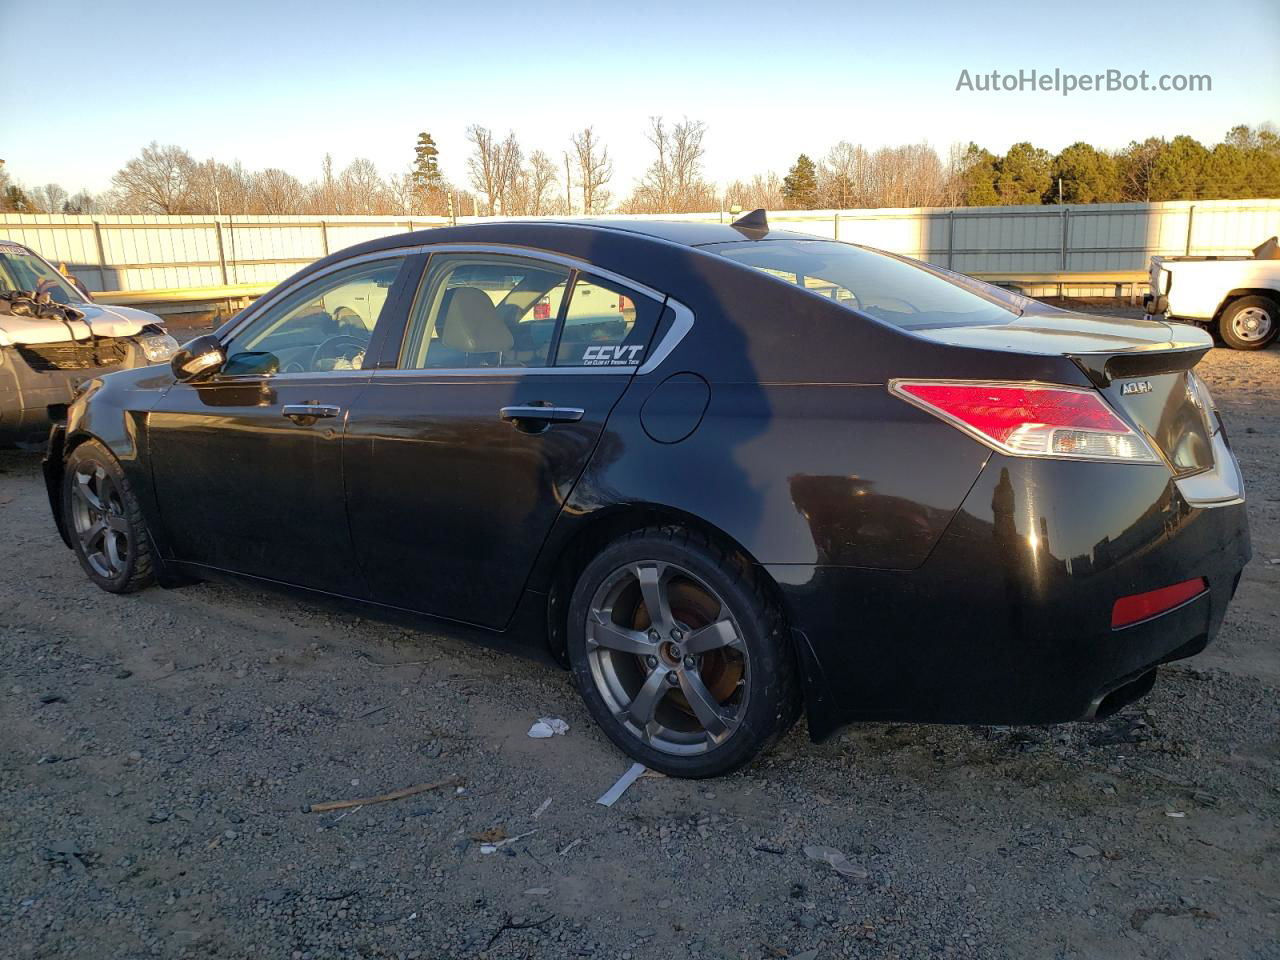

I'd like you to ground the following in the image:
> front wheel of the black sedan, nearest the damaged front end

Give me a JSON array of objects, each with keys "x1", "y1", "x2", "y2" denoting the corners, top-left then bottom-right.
[{"x1": 63, "y1": 440, "x2": 155, "y2": 594}]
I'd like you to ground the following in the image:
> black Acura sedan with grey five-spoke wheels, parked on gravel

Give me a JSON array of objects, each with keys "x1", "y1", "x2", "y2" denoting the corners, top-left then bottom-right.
[{"x1": 45, "y1": 211, "x2": 1249, "y2": 777}]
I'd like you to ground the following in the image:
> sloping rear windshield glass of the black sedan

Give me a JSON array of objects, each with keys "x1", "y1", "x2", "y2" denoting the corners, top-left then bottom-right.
[{"x1": 703, "y1": 239, "x2": 1024, "y2": 329}]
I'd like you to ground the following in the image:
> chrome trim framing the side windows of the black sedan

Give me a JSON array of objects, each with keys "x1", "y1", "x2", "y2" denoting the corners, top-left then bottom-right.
[{"x1": 221, "y1": 243, "x2": 694, "y2": 380}]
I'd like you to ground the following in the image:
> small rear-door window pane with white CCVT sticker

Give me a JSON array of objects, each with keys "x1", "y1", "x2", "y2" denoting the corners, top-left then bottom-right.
[{"x1": 556, "y1": 273, "x2": 662, "y2": 366}]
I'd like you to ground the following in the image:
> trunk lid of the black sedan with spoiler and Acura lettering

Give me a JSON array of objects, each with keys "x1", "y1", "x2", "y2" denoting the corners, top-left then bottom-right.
[{"x1": 913, "y1": 305, "x2": 1217, "y2": 476}]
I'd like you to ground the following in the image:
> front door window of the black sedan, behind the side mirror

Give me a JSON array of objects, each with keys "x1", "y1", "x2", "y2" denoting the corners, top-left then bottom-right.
[{"x1": 223, "y1": 257, "x2": 404, "y2": 374}]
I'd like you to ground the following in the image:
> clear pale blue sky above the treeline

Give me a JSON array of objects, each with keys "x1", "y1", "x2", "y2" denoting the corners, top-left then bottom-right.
[{"x1": 0, "y1": 0, "x2": 1280, "y2": 195}]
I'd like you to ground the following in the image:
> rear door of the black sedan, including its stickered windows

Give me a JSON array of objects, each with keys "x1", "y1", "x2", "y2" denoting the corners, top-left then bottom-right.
[{"x1": 344, "y1": 251, "x2": 662, "y2": 627}]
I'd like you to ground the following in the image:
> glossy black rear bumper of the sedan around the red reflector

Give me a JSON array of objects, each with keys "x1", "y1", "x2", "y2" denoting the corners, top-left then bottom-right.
[{"x1": 768, "y1": 456, "x2": 1249, "y2": 739}]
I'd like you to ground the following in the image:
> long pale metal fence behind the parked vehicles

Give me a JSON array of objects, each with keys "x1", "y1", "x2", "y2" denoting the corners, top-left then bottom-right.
[{"x1": 0, "y1": 200, "x2": 1280, "y2": 291}]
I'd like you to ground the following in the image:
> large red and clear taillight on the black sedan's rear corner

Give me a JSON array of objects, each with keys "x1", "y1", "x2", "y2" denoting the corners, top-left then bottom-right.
[{"x1": 890, "y1": 380, "x2": 1156, "y2": 462}]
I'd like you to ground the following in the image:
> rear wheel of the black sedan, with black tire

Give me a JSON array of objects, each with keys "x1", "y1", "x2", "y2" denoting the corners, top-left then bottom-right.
[{"x1": 567, "y1": 527, "x2": 800, "y2": 778}]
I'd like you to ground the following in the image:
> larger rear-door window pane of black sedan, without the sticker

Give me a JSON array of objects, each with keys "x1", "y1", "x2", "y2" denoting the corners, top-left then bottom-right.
[{"x1": 401, "y1": 253, "x2": 570, "y2": 370}]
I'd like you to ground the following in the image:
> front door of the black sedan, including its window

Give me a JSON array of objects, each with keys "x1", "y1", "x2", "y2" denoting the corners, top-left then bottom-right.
[{"x1": 147, "y1": 255, "x2": 410, "y2": 596}]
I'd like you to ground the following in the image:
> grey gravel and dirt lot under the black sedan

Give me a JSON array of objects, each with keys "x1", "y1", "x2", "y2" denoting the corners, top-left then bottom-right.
[{"x1": 0, "y1": 332, "x2": 1280, "y2": 960}]
